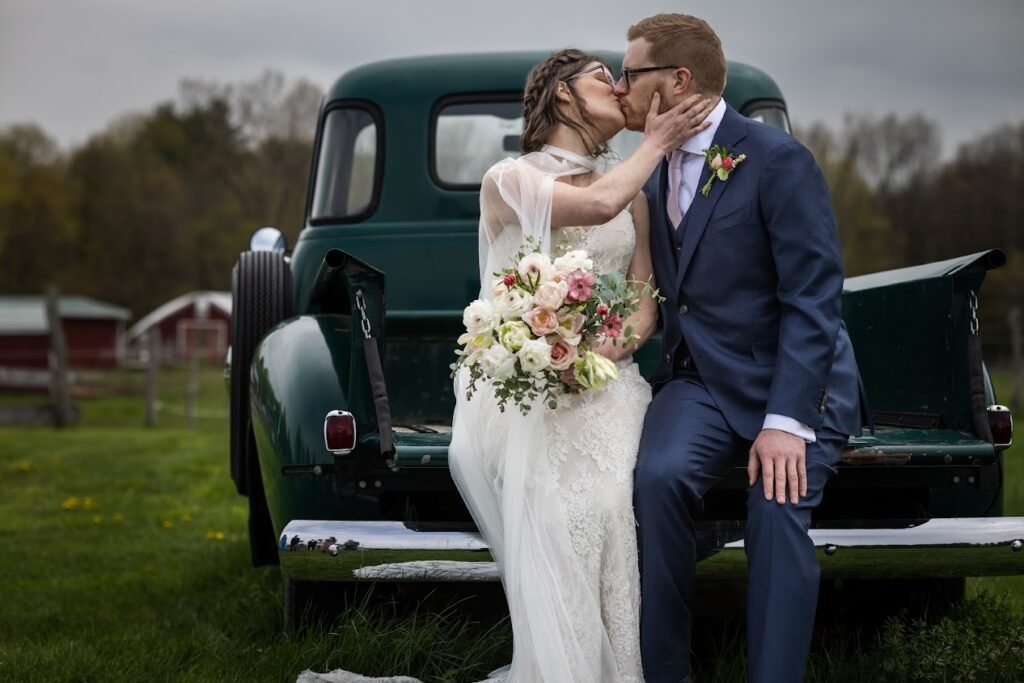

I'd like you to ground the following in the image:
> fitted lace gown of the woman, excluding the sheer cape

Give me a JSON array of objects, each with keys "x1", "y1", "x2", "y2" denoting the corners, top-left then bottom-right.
[{"x1": 545, "y1": 211, "x2": 650, "y2": 682}]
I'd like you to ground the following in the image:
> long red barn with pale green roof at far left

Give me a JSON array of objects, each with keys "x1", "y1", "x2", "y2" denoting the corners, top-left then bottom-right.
[{"x1": 0, "y1": 296, "x2": 131, "y2": 369}]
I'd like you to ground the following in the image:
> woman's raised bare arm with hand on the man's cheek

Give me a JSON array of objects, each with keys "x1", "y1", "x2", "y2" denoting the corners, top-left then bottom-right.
[{"x1": 551, "y1": 93, "x2": 714, "y2": 227}]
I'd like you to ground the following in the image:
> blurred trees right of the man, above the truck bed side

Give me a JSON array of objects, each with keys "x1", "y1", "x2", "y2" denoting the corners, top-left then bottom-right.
[{"x1": 795, "y1": 115, "x2": 1024, "y2": 362}]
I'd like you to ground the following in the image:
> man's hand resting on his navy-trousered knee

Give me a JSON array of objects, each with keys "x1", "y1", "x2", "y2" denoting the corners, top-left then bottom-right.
[{"x1": 746, "y1": 429, "x2": 807, "y2": 505}]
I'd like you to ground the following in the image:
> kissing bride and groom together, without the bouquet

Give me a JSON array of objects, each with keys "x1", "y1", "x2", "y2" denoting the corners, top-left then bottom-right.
[{"x1": 300, "y1": 9, "x2": 861, "y2": 683}]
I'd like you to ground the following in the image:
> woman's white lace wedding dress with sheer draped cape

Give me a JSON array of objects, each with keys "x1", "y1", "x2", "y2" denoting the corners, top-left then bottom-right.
[{"x1": 299, "y1": 147, "x2": 650, "y2": 683}]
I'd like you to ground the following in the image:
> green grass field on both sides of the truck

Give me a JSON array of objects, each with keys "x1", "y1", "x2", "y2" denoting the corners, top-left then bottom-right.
[{"x1": 0, "y1": 369, "x2": 1024, "y2": 683}]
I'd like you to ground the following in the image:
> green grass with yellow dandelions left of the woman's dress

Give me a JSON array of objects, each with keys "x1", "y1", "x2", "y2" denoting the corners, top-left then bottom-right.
[{"x1": 0, "y1": 371, "x2": 509, "y2": 681}]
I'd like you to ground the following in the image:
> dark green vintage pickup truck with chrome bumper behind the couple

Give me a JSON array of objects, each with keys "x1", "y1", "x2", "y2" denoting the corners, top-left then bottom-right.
[{"x1": 227, "y1": 52, "x2": 1024, "y2": 620}]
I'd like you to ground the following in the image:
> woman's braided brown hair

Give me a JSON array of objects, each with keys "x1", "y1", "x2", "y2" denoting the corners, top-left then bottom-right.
[{"x1": 520, "y1": 48, "x2": 608, "y2": 157}]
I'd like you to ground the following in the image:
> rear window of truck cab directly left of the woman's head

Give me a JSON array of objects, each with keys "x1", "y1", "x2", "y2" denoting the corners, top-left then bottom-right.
[{"x1": 430, "y1": 98, "x2": 523, "y2": 189}]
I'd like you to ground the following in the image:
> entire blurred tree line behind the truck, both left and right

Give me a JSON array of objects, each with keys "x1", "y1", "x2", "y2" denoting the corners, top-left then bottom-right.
[{"x1": 0, "y1": 72, "x2": 1024, "y2": 359}]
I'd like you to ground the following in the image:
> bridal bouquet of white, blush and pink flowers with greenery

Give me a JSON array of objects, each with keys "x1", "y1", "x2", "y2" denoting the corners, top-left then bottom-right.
[{"x1": 453, "y1": 242, "x2": 657, "y2": 415}]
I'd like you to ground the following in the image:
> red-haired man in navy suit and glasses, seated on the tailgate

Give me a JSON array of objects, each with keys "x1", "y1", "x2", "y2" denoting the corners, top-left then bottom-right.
[{"x1": 615, "y1": 14, "x2": 861, "y2": 683}]
